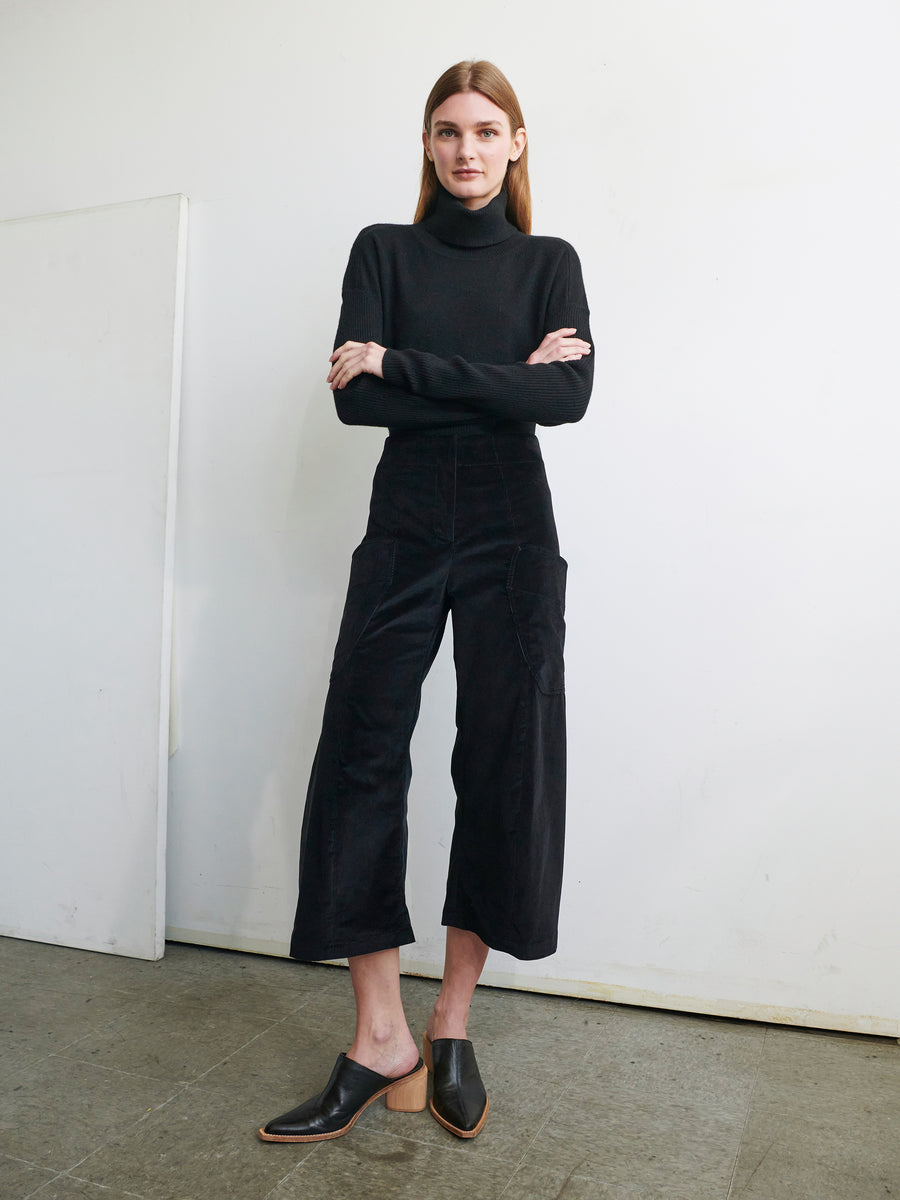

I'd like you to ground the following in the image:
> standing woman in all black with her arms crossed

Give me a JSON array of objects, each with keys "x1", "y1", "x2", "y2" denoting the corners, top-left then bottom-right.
[{"x1": 260, "y1": 62, "x2": 592, "y2": 1141}]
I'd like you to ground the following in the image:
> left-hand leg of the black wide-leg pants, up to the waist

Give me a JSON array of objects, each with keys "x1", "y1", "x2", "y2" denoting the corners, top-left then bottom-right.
[{"x1": 290, "y1": 439, "x2": 450, "y2": 961}]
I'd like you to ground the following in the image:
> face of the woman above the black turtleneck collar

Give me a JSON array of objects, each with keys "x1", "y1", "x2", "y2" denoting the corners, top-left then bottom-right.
[{"x1": 422, "y1": 91, "x2": 526, "y2": 209}]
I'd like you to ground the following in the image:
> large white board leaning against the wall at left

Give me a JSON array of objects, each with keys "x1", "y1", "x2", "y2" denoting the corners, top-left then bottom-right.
[{"x1": 0, "y1": 196, "x2": 187, "y2": 959}]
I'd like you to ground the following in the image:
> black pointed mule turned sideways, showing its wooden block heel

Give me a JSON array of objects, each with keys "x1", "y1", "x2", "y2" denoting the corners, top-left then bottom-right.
[{"x1": 259, "y1": 1054, "x2": 428, "y2": 1141}]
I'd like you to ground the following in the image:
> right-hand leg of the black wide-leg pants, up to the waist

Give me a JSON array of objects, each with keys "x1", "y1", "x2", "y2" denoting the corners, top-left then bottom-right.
[{"x1": 443, "y1": 439, "x2": 566, "y2": 959}]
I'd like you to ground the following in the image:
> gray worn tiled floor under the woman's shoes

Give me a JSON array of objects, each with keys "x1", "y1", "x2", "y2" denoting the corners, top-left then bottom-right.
[{"x1": 0, "y1": 938, "x2": 900, "y2": 1200}]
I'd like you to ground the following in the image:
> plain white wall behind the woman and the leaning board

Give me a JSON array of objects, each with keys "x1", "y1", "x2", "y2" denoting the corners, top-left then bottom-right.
[{"x1": 0, "y1": 0, "x2": 900, "y2": 1032}]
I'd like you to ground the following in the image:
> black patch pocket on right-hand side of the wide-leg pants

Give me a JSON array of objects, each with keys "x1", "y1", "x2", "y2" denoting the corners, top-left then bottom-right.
[{"x1": 506, "y1": 546, "x2": 568, "y2": 696}]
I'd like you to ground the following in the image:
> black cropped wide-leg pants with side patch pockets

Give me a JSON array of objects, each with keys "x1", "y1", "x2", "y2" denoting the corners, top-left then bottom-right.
[{"x1": 290, "y1": 432, "x2": 565, "y2": 961}]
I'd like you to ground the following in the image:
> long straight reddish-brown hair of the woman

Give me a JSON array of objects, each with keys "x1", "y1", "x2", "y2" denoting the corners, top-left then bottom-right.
[{"x1": 413, "y1": 60, "x2": 532, "y2": 233}]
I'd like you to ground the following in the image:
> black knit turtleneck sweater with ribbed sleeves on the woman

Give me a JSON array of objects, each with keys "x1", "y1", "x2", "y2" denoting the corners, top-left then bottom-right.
[{"x1": 334, "y1": 188, "x2": 594, "y2": 433}]
